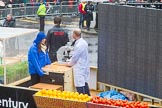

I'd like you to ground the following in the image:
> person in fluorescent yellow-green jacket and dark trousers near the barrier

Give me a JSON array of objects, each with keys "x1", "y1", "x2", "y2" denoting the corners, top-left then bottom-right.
[{"x1": 37, "y1": 0, "x2": 46, "y2": 31}]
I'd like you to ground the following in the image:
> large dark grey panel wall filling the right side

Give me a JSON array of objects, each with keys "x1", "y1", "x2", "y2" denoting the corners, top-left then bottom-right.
[{"x1": 98, "y1": 4, "x2": 162, "y2": 98}]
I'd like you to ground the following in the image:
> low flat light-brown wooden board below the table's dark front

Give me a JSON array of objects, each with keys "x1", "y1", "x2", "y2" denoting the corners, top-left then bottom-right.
[{"x1": 30, "y1": 83, "x2": 63, "y2": 91}]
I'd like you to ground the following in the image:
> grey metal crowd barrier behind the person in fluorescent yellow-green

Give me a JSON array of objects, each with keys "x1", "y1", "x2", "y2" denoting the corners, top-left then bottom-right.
[{"x1": 0, "y1": 2, "x2": 78, "y2": 19}]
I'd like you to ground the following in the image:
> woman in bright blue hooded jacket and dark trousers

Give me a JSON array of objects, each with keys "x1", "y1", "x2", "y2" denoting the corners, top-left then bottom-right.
[{"x1": 28, "y1": 32, "x2": 51, "y2": 85}]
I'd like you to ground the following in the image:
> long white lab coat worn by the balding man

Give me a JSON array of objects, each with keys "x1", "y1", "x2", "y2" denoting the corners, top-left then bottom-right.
[{"x1": 69, "y1": 38, "x2": 90, "y2": 87}]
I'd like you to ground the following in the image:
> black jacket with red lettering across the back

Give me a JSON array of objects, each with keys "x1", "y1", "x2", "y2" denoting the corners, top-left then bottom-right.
[{"x1": 47, "y1": 26, "x2": 69, "y2": 54}]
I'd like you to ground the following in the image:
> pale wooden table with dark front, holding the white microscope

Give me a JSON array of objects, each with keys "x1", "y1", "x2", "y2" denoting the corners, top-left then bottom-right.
[{"x1": 41, "y1": 63, "x2": 75, "y2": 91}]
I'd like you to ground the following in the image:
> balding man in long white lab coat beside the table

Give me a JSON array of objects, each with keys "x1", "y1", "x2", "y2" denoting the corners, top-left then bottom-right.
[{"x1": 67, "y1": 29, "x2": 90, "y2": 96}]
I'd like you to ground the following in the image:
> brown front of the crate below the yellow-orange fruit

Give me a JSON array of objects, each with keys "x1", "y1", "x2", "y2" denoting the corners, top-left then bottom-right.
[{"x1": 33, "y1": 95, "x2": 87, "y2": 108}]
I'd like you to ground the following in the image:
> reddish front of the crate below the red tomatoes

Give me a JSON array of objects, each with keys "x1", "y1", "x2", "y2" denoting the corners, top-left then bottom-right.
[{"x1": 87, "y1": 102, "x2": 121, "y2": 108}]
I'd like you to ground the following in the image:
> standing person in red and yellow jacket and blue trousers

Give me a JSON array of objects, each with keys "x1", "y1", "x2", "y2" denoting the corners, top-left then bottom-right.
[{"x1": 78, "y1": 1, "x2": 86, "y2": 28}]
